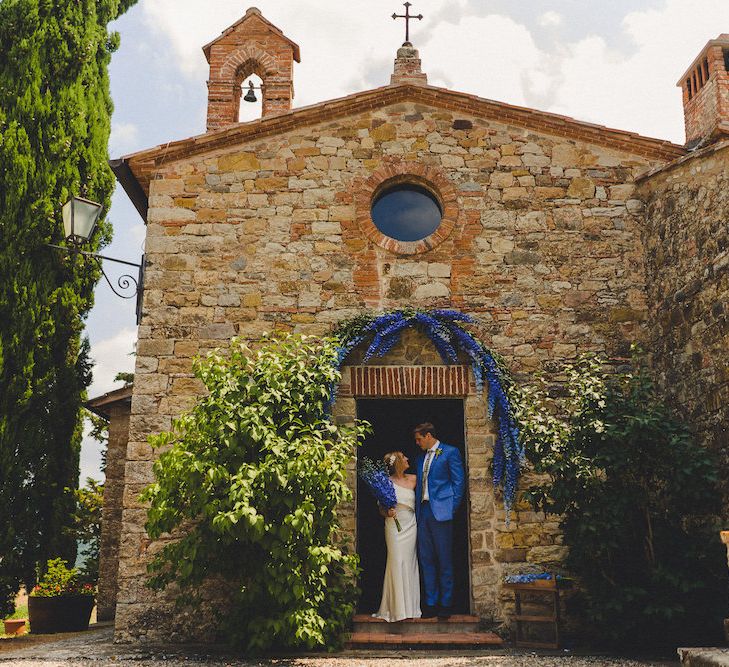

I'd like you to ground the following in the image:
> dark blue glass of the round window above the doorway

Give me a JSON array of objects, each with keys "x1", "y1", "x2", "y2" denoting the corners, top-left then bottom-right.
[{"x1": 372, "y1": 183, "x2": 443, "y2": 241}]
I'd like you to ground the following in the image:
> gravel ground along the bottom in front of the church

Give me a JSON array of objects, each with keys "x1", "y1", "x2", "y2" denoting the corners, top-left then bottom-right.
[{"x1": 0, "y1": 624, "x2": 678, "y2": 667}]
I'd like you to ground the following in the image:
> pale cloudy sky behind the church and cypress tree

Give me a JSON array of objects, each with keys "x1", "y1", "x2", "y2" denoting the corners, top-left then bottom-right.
[{"x1": 81, "y1": 0, "x2": 729, "y2": 479}]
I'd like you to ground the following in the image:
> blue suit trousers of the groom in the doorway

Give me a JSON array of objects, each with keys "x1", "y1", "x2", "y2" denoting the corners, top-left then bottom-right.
[{"x1": 418, "y1": 502, "x2": 453, "y2": 607}]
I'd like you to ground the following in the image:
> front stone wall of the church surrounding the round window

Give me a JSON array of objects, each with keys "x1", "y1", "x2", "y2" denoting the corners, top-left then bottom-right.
[{"x1": 117, "y1": 102, "x2": 655, "y2": 641}]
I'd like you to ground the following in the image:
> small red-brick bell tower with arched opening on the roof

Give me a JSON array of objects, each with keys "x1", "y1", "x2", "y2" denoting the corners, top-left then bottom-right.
[{"x1": 203, "y1": 7, "x2": 301, "y2": 132}]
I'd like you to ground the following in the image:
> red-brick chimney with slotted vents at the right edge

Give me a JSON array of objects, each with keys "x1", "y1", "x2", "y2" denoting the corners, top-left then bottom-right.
[{"x1": 676, "y1": 33, "x2": 729, "y2": 148}]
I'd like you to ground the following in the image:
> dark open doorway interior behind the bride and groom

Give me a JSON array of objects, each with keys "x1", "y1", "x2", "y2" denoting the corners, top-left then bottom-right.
[{"x1": 357, "y1": 398, "x2": 471, "y2": 614}]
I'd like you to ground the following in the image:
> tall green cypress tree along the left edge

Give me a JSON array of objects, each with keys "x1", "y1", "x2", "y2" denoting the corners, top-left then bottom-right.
[{"x1": 0, "y1": 0, "x2": 136, "y2": 614}]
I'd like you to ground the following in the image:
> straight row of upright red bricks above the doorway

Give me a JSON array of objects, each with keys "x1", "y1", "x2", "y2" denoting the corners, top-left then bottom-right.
[{"x1": 339, "y1": 365, "x2": 470, "y2": 397}]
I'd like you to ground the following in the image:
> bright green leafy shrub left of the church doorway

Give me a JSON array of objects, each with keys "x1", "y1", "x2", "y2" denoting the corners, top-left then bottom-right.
[{"x1": 143, "y1": 336, "x2": 366, "y2": 651}]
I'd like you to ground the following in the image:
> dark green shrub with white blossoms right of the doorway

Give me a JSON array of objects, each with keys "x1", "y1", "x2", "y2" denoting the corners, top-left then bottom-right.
[{"x1": 514, "y1": 358, "x2": 727, "y2": 647}]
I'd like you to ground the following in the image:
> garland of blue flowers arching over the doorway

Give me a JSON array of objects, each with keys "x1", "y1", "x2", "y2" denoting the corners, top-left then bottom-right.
[{"x1": 331, "y1": 309, "x2": 524, "y2": 520}]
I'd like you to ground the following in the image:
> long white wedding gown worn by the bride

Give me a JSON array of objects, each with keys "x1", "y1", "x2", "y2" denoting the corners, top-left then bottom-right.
[{"x1": 375, "y1": 484, "x2": 420, "y2": 622}]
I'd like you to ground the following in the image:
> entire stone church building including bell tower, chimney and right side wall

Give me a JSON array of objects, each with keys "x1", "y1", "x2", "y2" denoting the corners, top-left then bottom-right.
[{"x1": 102, "y1": 9, "x2": 729, "y2": 641}]
